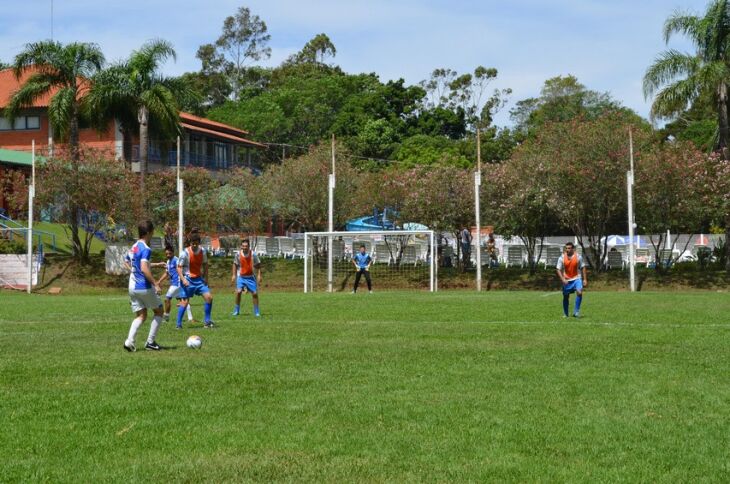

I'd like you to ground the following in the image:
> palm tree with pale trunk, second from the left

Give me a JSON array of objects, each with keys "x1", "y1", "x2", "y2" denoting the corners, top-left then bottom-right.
[{"x1": 88, "y1": 40, "x2": 186, "y2": 189}]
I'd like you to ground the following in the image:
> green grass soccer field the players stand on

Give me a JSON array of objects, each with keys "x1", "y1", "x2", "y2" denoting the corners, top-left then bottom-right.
[{"x1": 0, "y1": 292, "x2": 730, "y2": 482}]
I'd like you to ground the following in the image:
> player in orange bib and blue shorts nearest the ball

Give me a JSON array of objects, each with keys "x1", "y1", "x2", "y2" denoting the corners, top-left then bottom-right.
[{"x1": 177, "y1": 232, "x2": 214, "y2": 328}]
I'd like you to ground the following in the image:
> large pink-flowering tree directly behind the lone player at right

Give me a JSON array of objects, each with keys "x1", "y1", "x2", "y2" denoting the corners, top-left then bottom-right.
[{"x1": 515, "y1": 111, "x2": 651, "y2": 269}]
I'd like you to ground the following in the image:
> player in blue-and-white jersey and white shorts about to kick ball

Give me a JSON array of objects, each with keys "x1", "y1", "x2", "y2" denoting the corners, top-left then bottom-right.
[{"x1": 124, "y1": 221, "x2": 162, "y2": 351}]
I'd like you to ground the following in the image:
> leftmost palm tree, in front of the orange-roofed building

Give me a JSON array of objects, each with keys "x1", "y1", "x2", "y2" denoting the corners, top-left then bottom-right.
[{"x1": 5, "y1": 41, "x2": 104, "y2": 261}]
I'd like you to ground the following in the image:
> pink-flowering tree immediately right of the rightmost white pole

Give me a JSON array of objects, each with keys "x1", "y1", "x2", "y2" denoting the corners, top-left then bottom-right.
[{"x1": 634, "y1": 143, "x2": 721, "y2": 270}]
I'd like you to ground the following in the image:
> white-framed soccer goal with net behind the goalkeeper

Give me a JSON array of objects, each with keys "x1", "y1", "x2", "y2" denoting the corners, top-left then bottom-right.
[{"x1": 304, "y1": 230, "x2": 436, "y2": 292}]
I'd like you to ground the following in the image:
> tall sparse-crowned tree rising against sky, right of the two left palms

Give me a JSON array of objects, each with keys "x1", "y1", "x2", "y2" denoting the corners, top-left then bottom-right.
[{"x1": 198, "y1": 7, "x2": 271, "y2": 99}]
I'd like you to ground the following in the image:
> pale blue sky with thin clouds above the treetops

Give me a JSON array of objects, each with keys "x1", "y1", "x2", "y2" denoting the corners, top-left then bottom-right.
[{"x1": 0, "y1": 0, "x2": 709, "y2": 125}]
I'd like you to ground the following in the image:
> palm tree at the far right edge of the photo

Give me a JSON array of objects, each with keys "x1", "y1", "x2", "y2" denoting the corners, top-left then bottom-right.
[{"x1": 644, "y1": 0, "x2": 730, "y2": 159}]
